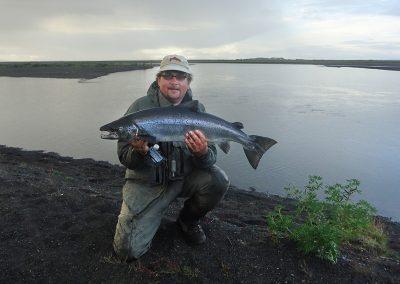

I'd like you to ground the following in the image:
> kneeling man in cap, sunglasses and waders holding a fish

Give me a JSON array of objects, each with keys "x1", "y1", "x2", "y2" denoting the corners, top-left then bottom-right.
[{"x1": 114, "y1": 55, "x2": 229, "y2": 260}]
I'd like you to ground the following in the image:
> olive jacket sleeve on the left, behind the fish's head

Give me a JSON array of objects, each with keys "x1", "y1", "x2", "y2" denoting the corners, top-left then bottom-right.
[{"x1": 117, "y1": 102, "x2": 145, "y2": 170}]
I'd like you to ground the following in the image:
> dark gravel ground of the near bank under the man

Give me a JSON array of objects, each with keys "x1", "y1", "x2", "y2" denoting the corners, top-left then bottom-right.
[{"x1": 0, "y1": 146, "x2": 400, "y2": 283}]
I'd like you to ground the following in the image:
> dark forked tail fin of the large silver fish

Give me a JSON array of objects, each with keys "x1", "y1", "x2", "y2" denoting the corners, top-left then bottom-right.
[{"x1": 243, "y1": 135, "x2": 277, "y2": 169}]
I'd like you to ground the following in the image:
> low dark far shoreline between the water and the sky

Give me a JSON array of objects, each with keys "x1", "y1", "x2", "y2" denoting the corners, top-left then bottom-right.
[{"x1": 0, "y1": 58, "x2": 400, "y2": 80}]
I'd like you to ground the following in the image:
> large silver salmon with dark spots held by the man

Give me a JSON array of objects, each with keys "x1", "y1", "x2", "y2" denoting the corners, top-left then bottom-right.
[{"x1": 100, "y1": 101, "x2": 277, "y2": 169}]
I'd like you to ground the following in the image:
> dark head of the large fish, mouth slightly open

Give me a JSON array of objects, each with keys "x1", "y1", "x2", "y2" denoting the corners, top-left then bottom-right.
[{"x1": 100, "y1": 118, "x2": 139, "y2": 140}]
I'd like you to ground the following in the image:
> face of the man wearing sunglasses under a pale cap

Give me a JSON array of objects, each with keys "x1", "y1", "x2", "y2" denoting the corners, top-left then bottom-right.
[{"x1": 157, "y1": 71, "x2": 190, "y2": 105}]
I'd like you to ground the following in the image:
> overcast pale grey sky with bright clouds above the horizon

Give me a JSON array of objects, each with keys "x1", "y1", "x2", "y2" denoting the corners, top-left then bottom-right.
[{"x1": 0, "y1": 0, "x2": 400, "y2": 61}]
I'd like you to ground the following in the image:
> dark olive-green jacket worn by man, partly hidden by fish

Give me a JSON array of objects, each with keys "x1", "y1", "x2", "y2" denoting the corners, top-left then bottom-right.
[{"x1": 118, "y1": 82, "x2": 217, "y2": 182}]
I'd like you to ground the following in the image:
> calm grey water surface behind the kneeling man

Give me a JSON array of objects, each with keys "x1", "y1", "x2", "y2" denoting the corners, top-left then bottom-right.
[{"x1": 0, "y1": 64, "x2": 400, "y2": 220}]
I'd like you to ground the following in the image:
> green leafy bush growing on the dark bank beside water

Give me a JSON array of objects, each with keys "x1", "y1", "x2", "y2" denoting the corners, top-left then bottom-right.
[{"x1": 267, "y1": 176, "x2": 386, "y2": 263}]
